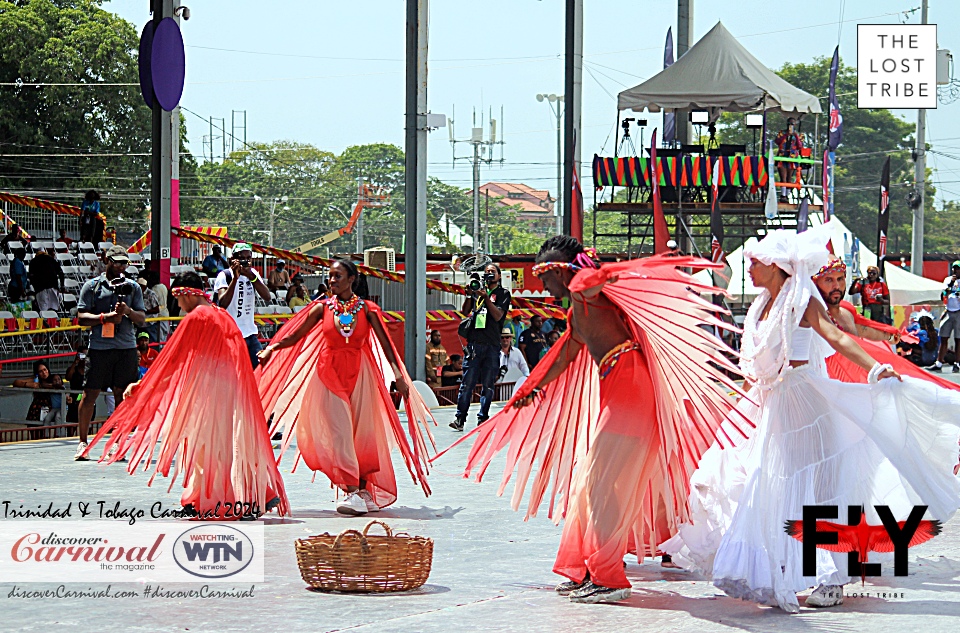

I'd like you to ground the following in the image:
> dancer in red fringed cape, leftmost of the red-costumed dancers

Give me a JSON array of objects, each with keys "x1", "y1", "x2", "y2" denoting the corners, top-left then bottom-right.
[{"x1": 87, "y1": 273, "x2": 289, "y2": 520}]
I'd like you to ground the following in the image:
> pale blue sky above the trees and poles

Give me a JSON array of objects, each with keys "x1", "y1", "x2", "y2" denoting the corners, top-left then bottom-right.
[{"x1": 104, "y1": 0, "x2": 960, "y2": 206}]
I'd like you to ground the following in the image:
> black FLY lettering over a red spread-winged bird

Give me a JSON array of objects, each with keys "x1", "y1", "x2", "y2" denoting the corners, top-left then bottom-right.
[{"x1": 784, "y1": 506, "x2": 941, "y2": 582}]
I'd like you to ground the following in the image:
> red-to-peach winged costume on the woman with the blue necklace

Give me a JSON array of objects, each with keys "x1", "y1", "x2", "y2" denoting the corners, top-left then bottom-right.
[{"x1": 257, "y1": 301, "x2": 436, "y2": 508}]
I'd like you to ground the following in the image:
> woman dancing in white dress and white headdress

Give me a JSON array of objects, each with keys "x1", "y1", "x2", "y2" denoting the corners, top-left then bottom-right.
[{"x1": 661, "y1": 227, "x2": 960, "y2": 613}]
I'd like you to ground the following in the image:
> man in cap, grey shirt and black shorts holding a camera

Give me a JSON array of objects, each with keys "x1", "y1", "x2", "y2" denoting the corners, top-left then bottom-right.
[{"x1": 74, "y1": 246, "x2": 146, "y2": 461}]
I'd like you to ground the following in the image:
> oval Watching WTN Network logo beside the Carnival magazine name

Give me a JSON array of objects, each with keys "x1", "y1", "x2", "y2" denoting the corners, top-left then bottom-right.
[{"x1": 173, "y1": 524, "x2": 255, "y2": 578}]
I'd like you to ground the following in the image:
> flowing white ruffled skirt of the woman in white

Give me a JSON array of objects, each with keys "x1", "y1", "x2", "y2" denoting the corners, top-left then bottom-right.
[{"x1": 661, "y1": 366, "x2": 960, "y2": 612}]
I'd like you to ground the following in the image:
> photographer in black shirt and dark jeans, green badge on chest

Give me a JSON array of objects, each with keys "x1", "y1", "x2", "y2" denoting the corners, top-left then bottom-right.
[{"x1": 450, "y1": 264, "x2": 511, "y2": 431}]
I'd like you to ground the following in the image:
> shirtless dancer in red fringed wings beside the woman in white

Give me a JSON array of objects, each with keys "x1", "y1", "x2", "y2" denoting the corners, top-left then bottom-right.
[{"x1": 442, "y1": 236, "x2": 746, "y2": 602}]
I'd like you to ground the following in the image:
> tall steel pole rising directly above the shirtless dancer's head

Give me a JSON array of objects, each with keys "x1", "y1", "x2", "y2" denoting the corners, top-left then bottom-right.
[{"x1": 557, "y1": 0, "x2": 583, "y2": 235}]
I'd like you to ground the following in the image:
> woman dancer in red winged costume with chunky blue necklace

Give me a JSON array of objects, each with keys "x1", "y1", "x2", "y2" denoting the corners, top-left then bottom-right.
[{"x1": 260, "y1": 260, "x2": 433, "y2": 515}]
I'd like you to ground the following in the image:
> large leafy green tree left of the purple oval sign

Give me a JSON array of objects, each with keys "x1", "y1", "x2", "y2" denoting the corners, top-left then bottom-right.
[{"x1": 0, "y1": 0, "x2": 151, "y2": 217}]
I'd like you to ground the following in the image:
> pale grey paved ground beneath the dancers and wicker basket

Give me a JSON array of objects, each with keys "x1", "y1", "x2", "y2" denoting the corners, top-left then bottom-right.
[{"x1": 0, "y1": 400, "x2": 960, "y2": 633}]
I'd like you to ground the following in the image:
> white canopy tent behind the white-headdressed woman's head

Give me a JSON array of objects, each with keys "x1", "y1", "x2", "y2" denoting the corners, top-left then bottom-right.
[{"x1": 694, "y1": 214, "x2": 943, "y2": 305}]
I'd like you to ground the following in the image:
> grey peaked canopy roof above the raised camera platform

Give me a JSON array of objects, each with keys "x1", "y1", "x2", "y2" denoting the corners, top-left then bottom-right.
[{"x1": 617, "y1": 22, "x2": 821, "y2": 114}]
